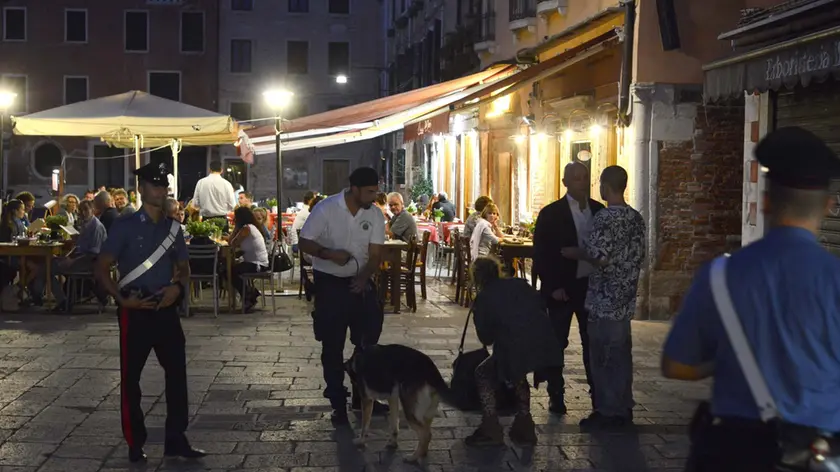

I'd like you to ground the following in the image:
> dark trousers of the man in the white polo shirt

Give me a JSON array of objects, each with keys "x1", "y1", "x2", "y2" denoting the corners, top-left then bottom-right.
[{"x1": 312, "y1": 271, "x2": 384, "y2": 409}]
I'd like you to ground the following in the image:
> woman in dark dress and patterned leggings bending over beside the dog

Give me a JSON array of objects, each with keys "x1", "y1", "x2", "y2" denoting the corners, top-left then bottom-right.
[{"x1": 465, "y1": 257, "x2": 563, "y2": 446}]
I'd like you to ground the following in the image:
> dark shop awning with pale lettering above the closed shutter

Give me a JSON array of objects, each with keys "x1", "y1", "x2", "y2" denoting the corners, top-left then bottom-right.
[{"x1": 703, "y1": 27, "x2": 840, "y2": 101}]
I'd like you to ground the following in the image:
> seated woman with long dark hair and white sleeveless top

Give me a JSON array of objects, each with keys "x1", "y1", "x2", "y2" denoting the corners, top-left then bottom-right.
[{"x1": 229, "y1": 206, "x2": 268, "y2": 313}]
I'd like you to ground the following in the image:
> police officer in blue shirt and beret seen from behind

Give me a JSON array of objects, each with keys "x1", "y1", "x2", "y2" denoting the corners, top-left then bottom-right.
[{"x1": 662, "y1": 127, "x2": 840, "y2": 472}]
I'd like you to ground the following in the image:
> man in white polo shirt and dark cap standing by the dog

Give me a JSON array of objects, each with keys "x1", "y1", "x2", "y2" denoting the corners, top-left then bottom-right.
[{"x1": 298, "y1": 167, "x2": 385, "y2": 426}]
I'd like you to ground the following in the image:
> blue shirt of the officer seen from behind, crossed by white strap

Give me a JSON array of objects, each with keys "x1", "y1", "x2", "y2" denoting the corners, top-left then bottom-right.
[{"x1": 664, "y1": 227, "x2": 840, "y2": 432}]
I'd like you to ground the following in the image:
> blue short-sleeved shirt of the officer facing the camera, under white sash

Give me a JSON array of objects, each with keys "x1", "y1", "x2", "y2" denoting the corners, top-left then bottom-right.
[{"x1": 101, "y1": 208, "x2": 189, "y2": 293}]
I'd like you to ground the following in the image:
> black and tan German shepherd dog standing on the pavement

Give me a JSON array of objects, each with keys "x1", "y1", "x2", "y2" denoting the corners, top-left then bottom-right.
[{"x1": 344, "y1": 344, "x2": 456, "y2": 463}]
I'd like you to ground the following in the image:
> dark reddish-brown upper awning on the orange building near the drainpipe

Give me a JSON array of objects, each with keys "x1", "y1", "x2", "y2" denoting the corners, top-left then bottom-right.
[{"x1": 450, "y1": 29, "x2": 618, "y2": 111}]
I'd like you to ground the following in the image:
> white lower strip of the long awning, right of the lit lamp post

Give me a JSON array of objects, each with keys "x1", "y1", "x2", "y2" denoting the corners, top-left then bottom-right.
[{"x1": 249, "y1": 75, "x2": 504, "y2": 154}]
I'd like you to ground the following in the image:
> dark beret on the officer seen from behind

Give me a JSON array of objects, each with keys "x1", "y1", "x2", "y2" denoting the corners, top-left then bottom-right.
[{"x1": 755, "y1": 126, "x2": 840, "y2": 190}]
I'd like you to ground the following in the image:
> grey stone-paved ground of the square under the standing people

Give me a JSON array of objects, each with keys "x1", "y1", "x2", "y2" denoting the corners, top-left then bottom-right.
[{"x1": 0, "y1": 285, "x2": 707, "y2": 472}]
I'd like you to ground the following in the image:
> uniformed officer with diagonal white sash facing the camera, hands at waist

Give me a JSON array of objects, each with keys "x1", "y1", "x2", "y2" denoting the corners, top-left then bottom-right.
[{"x1": 96, "y1": 160, "x2": 205, "y2": 462}]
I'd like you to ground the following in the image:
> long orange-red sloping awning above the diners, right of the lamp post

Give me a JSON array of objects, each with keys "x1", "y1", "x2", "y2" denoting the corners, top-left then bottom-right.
[{"x1": 248, "y1": 66, "x2": 512, "y2": 144}]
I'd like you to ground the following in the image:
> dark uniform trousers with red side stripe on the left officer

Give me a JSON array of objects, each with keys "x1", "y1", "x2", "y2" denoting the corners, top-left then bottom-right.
[{"x1": 118, "y1": 305, "x2": 189, "y2": 447}]
